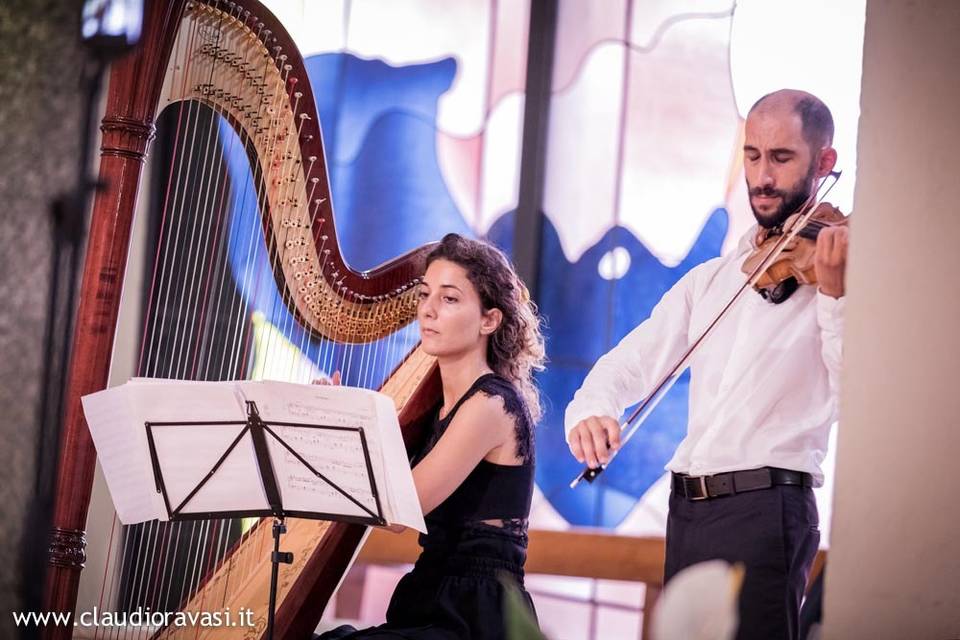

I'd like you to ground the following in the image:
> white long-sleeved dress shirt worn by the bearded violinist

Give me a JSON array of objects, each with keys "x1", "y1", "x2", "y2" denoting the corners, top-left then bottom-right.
[{"x1": 564, "y1": 226, "x2": 844, "y2": 486}]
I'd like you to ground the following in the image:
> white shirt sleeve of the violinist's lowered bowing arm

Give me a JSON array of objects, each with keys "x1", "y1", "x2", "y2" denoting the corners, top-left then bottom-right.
[{"x1": 564, "y1": 265, "x2": 704, "y2": 436}]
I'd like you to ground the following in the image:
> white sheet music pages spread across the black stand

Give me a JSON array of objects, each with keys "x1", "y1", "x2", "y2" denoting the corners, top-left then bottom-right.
[{"x1": 83, "y1": 378, "x2": 426, "y2": 531}]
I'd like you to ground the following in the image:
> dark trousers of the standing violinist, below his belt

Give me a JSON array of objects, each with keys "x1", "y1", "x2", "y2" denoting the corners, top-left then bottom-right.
[{"x1": 664, "y1": 486, "x2": 820, "y2": 640}]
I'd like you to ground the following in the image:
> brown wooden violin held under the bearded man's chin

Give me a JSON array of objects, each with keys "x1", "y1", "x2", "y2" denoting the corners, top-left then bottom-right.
[{"x1": 741, "y1": 202, "x2": 849, "y2": 304}]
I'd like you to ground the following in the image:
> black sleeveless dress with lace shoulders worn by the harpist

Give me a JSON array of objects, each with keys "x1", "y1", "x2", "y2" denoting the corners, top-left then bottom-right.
[{"x1": 320, "y1": 374, "x2": 534, "y2": 640}]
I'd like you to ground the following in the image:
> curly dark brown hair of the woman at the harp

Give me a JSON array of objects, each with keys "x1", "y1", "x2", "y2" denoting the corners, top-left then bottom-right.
[{"x1": 427, "y1": 233, "x2": 546, "y2": 422}]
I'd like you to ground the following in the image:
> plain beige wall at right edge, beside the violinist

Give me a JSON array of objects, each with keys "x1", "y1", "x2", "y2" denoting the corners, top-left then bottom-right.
[{"x1": 824, "y1": 0, "x2": 960, "y2": 640}]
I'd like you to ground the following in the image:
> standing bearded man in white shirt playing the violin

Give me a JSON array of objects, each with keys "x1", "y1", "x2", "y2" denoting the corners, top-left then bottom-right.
[{"x1": 565, "y1": 89, "x2": 848, "y2": 639}]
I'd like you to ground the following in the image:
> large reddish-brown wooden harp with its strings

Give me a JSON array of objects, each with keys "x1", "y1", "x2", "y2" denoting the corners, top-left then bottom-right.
[{"x1": 45, "y1": 0, "x2": 440, "y2": 638}]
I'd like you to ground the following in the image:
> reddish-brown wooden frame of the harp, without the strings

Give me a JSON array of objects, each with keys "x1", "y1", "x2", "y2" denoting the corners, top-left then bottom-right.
[{"x1": 47, "y1": 0, "x2": 439, "y2": 637}]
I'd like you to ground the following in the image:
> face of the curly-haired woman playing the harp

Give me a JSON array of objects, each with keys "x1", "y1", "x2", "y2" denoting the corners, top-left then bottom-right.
[{"x1": 417, "y1": 259, "x2": 501, "y2": 356}]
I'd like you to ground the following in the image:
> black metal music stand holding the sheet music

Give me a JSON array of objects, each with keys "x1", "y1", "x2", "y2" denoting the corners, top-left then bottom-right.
[{"x1": 144, "y1": 400, "x2": 387, "y2": 640}]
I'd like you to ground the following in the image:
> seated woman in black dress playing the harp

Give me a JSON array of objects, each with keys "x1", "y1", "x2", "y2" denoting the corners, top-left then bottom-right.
[{"x1": 320, "y1": 234, "x2": 543, "y2": 640}]
